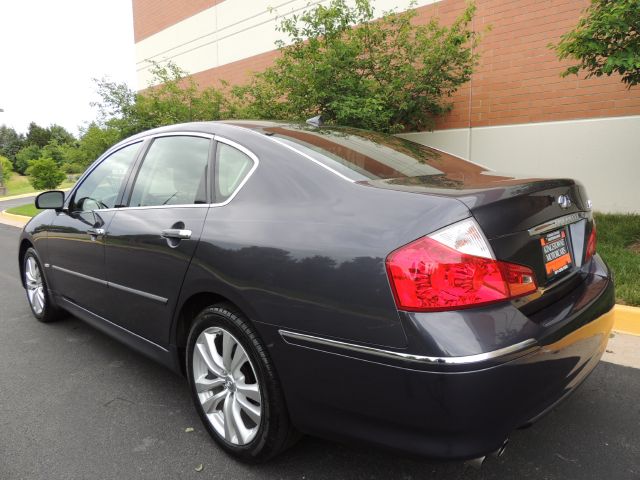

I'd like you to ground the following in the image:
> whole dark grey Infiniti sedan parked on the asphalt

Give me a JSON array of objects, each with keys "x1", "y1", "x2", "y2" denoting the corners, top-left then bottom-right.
[{"x1": 19, "y1": 121, "x2": 614, "y2": 462}]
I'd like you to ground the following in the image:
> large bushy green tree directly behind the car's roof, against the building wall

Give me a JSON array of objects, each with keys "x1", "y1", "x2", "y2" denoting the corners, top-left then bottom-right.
[{"x1": 233, "y1": 0, "x2": 479, "y2": 132}]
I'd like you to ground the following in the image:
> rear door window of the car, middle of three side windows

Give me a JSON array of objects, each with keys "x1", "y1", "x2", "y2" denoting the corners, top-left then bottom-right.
[{"x1": 129, "y1": 135, "x2": 211, "y2": 207}]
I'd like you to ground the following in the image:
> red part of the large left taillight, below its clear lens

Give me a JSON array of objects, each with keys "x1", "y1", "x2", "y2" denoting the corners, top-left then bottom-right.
[{"x1": 386, "y1": 237, "x2": 537, "y2": 311}]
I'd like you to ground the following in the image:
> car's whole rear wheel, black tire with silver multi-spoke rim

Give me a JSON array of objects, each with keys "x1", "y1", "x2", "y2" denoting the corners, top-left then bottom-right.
[{"x1": 187, "y1": 304, "x2": 297, "y2": 463}]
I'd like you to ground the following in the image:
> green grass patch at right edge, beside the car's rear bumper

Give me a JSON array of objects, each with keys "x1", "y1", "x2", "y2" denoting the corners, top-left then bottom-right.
[{"x1": 596, "y1": 213, "x2": 640, "y2": 306}]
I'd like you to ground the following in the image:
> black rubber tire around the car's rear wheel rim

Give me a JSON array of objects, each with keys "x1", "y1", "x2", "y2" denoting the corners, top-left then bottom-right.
[{"x1": 186, "y1": 304, "x2": 299, "y2": 463}]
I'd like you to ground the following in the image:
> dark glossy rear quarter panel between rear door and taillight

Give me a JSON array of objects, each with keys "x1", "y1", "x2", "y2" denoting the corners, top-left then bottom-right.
[{"x1": 182, "y1": 132, "x2": 469, "y2": 348}]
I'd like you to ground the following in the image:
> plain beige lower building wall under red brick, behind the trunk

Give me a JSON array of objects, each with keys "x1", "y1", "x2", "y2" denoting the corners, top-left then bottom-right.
[{"x1": 402, "y1": 115, "x2": 640, "y2": 213}]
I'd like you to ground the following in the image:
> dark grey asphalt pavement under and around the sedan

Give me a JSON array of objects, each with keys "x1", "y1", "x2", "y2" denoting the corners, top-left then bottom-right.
[{"x1": 0, "y1": 225, "x2": 640, "y2": 480}]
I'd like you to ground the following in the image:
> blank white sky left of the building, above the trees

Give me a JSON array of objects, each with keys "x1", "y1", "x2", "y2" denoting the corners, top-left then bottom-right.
[{"x1": 0, "y1": 0, "x2": 136, "y2": 135}]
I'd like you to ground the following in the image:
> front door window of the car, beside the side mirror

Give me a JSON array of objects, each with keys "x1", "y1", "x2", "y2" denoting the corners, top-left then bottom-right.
[{"x1": 71, "y1": 142, "x2": 140, "y2": 211}]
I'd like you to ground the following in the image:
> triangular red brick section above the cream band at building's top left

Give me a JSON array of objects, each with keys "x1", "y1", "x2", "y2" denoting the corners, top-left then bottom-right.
[{"x1": 132, "y1": 0, "x2": 224, "y2": 43}]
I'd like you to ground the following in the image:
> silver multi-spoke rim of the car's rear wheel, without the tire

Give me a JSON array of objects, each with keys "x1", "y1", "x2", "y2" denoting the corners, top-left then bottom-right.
[{"x1": 193, "y1": 327, "x2": 262, "y2": 445}]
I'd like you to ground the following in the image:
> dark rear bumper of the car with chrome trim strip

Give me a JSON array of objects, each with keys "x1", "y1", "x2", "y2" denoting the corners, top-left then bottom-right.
[{"x1": 260, "y1": 253, "x2": 614, "y2": 459}]
